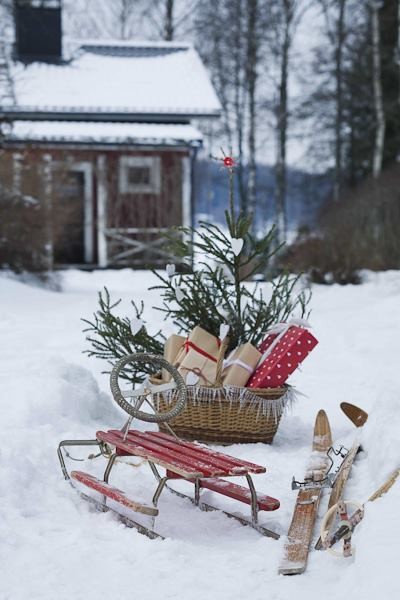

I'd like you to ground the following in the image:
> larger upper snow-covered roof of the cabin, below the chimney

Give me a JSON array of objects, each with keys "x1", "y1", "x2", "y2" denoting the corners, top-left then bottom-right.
[{"x1": 2, "y1": 41, "x2": 221, "y2": 120}]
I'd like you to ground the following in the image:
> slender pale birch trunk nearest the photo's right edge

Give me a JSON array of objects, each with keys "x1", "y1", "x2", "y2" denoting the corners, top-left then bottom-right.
[{"x1": 370, "y1": 0, "x2": 386, "y2": 178}]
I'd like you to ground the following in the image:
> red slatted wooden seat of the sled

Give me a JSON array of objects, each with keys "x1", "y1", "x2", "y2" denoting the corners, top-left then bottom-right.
[{"x1": 96, "y1": 430, "x2": 266, "y2": 479}]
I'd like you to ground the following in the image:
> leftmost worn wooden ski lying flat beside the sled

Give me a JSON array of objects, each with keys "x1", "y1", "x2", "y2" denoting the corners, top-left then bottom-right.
[{"x1": 279, "y1": 410, "x2": 332, "y2": 575}]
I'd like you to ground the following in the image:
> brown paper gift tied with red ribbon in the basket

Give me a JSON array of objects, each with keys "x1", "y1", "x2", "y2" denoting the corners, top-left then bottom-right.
[{"x1": 177, "y1": 327, "x2": 221, "y2": 385}]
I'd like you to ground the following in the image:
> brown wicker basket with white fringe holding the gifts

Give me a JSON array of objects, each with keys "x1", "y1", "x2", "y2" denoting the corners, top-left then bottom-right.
[{"x1": 154, "y1": 340, "x2": 293, "y2": 444}]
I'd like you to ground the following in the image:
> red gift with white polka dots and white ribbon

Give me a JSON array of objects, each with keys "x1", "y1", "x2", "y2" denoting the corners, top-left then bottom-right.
[{"x1": 246, "y1": 319, "x2": 318, "y2": 388}]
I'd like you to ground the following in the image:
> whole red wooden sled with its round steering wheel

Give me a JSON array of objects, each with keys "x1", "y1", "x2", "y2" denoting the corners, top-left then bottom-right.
[{"x1": 58, "y1": 354, "x2": 279, "y2": 539}]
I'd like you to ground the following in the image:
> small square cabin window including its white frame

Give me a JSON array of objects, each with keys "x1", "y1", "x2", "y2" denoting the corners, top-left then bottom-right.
[{"x1": 119, "y1": 156, "x2": 160, "y2": 194}]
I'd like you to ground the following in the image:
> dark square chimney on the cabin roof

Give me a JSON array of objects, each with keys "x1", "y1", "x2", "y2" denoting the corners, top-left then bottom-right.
[{"x1": 14, "y1": 0, "x2": 62, "y2": 63}]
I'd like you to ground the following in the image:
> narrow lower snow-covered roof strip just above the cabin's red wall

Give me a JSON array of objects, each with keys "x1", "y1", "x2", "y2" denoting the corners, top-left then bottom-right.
[{"x1": 6, "y1": 121, "x2": 202, "y2": 146}]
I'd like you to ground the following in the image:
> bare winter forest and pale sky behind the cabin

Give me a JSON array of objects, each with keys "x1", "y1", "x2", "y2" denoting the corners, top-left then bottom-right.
[{"x1": 0, "y1": 0, "x2": 400, "y2": 279}]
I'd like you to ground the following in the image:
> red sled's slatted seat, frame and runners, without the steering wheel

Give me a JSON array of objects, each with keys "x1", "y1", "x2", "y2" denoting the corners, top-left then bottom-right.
[{"x1": 58, "y1": 429, "x2": 279, "y2": 539}]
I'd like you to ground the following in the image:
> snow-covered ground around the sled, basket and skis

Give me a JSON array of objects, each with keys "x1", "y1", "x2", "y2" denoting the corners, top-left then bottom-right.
[{"x1": 0, "y1": 270, "x2": 400, "y2": 600}]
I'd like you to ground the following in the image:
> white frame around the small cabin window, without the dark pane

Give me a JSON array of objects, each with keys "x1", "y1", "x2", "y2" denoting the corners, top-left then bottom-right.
[{"x1": 119, "y1": 156, "x2": 161, "y2": 195}]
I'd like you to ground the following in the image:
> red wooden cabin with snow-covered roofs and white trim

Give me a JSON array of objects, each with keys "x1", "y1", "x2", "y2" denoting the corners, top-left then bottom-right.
[{"x1": 0, "y1": 3, "x2": 220, "y2": 267}]
